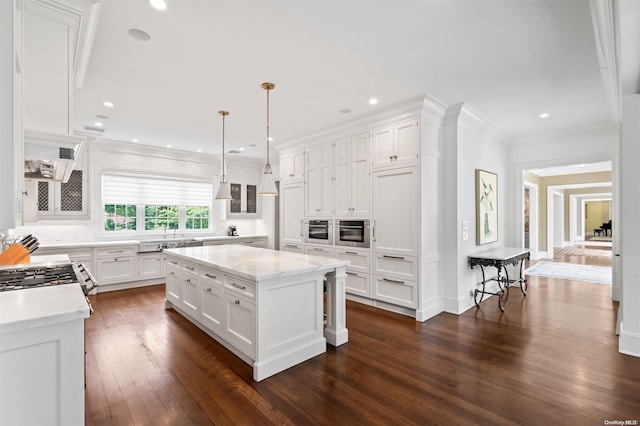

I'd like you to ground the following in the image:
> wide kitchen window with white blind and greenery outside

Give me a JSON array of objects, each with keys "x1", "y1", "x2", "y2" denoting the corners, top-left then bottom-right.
[{"x1": 102, "y1": 174, "x2": 213, "y2": 233}]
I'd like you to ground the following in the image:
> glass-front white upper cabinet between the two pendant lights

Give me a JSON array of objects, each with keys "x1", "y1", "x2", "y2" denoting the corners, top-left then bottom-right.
[{"x1": 227, "y1": 165, "x2": 260, "y2": 219}]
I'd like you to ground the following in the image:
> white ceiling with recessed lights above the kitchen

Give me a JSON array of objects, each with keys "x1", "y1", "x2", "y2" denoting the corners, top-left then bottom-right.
[{"x1": 74, "y1": 0, "x2": 611, "y2": 158}]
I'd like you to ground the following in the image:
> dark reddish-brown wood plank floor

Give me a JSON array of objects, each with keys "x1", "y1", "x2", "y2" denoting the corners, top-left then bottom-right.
[{"x1": 86, "y1": 248, "x2": 640, "y2": 425}]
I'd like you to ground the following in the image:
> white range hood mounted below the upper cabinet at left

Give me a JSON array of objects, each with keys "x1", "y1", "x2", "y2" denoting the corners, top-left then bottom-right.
[{"x1": 24, "y1": 130, "x2": 86, "y2": 182}]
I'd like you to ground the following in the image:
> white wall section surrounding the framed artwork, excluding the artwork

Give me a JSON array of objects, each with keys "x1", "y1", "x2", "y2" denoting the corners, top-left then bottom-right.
[{"x1": 443, "y1": 104, "x2": 508, "y2": 314}]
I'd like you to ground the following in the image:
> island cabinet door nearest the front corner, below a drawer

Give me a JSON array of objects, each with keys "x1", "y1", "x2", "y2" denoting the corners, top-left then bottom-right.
[{"x1": 225, "y1": 292, "x2": 256, "y2": 358}]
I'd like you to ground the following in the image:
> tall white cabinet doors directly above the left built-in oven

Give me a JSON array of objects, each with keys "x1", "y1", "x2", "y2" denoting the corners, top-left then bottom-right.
[{"x1": 305, "y1": 144, "x2": 333, "y2": 216}]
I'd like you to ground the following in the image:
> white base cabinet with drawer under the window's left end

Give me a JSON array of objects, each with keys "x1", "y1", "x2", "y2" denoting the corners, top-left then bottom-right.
[{"x1": 95, "y1": 245, "x2": 138, "y2": 285}]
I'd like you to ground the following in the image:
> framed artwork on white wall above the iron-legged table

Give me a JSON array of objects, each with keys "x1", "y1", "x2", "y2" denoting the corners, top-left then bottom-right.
[{"x1": 476, "y1": 169, "x2": 498, "y2": 245}]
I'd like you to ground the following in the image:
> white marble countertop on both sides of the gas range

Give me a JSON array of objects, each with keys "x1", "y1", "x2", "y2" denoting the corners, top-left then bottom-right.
[{"x1": 0, "y1": 255, "x2": 89, "y2": 334}]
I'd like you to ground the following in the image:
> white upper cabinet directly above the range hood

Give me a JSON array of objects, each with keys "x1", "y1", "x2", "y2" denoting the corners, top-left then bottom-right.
[{"x1": 23, "y1": 0, "x2": 82, "y2": 135}]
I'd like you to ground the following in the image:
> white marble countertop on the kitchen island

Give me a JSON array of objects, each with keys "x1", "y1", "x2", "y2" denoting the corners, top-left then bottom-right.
[{"x1": 164, "y1": 244, "x2": 349, "y2": 281}]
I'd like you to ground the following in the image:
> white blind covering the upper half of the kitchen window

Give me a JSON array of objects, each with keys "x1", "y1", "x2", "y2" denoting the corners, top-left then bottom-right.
[{"x1": 102, "y1": 174, "x2": 213, "y2": 206}]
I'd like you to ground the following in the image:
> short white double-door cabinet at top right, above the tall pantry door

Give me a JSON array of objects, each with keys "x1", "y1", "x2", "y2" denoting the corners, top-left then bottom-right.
[{"x1": 372, "y1": 119, "x2": 419, "y2": 169}]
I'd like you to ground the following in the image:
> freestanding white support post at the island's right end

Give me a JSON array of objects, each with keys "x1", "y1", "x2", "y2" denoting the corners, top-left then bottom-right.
[{"x1": 324, "y1": 266, "x2": 349, "y2": 346}]
